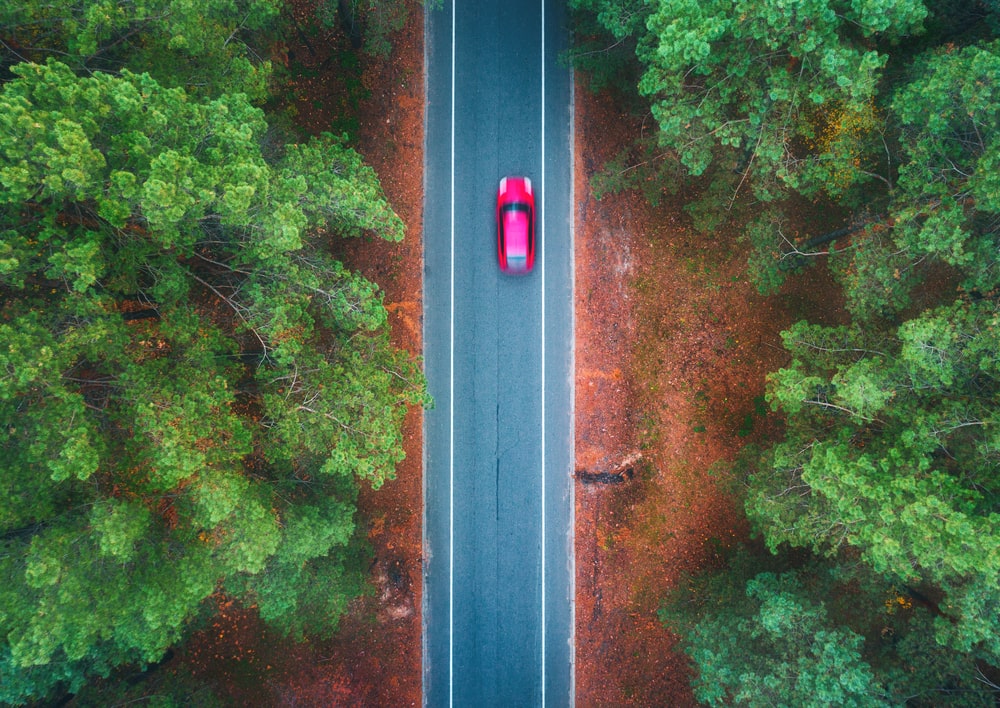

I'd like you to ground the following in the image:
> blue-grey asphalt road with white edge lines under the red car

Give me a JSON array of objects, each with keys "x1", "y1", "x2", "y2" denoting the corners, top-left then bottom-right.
[{"x1": 423, "y1": 0, "x2": 573, "y2": 706}]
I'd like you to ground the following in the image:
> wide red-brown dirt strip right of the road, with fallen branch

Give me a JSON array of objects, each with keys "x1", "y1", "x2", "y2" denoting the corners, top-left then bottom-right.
[{"x1": 575, "y1": 76, "x2": 837, "y2": 706}]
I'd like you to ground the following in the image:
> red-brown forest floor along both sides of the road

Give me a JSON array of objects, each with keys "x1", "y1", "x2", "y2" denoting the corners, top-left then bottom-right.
[{"x1": 176, "y1": 0, "x2": 837, "y2": 706}]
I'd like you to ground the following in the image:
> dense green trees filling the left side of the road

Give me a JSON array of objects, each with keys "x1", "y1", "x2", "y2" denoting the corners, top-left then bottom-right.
[{"x1": 0, "y1": 0, "x2": 428, "y2": 705}]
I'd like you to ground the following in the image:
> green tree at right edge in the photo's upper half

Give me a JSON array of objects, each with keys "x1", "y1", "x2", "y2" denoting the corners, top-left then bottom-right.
[{"x1": 750, "y1": 42, "x2": 1000, "y2": 318}]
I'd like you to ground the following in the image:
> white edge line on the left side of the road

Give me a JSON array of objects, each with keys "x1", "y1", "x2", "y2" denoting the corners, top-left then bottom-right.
[{"x1": 448, "y1": 0, "x2": 456, "y2": 706}]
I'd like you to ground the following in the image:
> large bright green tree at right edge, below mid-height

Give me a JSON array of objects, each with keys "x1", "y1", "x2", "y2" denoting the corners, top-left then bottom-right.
[{"x1": 747, "y1": 301, "x2": 1000, "y2": 663}]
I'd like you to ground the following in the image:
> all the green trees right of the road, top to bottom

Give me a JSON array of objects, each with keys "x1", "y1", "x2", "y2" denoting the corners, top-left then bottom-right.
[{"x1": 569, "y1": 0, "x2": 1000, "y2": 706}]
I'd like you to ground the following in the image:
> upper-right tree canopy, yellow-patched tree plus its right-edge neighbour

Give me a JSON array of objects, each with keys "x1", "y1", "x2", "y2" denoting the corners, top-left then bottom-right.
[{"x1": 571, "y1": 0, "x2": 998, "y2": 317}]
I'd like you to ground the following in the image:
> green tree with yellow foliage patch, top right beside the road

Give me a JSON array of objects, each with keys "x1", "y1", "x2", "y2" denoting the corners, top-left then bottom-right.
[{"x1": 574, "y1": 0, "x2": 927, "y2": 200}]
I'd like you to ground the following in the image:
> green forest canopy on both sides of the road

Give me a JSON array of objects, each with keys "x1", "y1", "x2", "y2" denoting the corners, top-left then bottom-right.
[{"x1": 0, "y1": 0, "x2": 1000, "y2": 706}]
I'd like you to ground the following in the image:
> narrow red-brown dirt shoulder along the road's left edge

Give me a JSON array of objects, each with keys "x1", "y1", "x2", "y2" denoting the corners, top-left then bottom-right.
[{"x1": 322, "y1": 0, "x2": 424, "y2": 706}]
